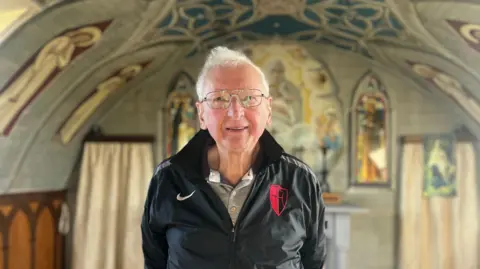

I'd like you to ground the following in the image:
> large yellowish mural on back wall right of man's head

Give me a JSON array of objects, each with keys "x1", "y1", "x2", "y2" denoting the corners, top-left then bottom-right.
[{"x1": 241, "y1": 43, "x2": 344, "y2": 172}]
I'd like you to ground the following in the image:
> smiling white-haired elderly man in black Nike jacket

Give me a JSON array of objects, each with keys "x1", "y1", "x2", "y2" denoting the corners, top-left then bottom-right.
[{"x1": 141, "y1": 47, "x2": 326, "y2": 269}]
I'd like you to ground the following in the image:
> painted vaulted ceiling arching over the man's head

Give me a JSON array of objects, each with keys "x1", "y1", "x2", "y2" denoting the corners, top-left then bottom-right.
[{"x1": 0, "y1": 0, "x2": 480, "y2": 191}]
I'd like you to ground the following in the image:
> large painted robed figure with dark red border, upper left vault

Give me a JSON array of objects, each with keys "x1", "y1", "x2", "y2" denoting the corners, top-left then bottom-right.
[{"x1": 0, "y1": 21, "x2": 111, "y2": 136}]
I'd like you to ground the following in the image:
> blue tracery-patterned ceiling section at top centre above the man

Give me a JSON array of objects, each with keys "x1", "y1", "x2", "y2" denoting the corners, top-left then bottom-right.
[{"x1": 153, "y1": 0, "x2": 411, "y2": 57}]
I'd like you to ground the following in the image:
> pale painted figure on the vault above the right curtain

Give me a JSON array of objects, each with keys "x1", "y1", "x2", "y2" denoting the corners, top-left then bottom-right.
[{"x1": 407, "y1": 61, "x2": 480, "y2": 123}]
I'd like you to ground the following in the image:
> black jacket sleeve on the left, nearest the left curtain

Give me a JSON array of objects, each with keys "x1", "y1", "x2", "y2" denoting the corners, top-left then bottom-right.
[{"x1": 141, "y1": 164, "x2": 169, "y2": 269}]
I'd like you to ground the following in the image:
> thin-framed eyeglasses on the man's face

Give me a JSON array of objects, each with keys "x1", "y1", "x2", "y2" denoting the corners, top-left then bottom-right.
[{"x1": 201, "y1": 89, "x2": 266, "y2": 109}]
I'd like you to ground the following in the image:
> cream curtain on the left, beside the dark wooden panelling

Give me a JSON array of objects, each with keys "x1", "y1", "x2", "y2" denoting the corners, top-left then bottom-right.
[{"x1": 72, "y1": 142, "x2": 153, "y2": 269}]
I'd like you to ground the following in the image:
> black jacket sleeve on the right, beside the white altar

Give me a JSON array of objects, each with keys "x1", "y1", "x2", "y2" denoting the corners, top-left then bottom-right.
[{"x1": 300, "y1": 172, "x2": 327, "y2": 269}]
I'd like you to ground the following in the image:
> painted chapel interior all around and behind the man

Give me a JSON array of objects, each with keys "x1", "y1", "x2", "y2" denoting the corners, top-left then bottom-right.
[{"x1": 0, "y1": 0, "x2": 480, "y2": 269}]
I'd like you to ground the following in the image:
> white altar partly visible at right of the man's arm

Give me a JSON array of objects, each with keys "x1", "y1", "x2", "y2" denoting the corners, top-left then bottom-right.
[{"x1": 324, "y1": 203, "x2": 368, "y2": 269}]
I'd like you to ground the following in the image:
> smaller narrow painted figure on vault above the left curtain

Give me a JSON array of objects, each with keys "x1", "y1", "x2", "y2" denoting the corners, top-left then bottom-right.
[{"x1": 58, "y1": 62, "x2": 150, "y2": 144}]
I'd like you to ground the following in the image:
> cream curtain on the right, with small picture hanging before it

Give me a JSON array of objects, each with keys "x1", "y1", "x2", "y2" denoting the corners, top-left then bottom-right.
[{"x1": 400, "y1": 143, "x2": 480, "y2": 269}]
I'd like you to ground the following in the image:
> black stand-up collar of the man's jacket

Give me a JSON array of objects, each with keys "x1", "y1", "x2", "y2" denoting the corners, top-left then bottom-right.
[{"x1": 170, "y1": 130, "x2": 284, "y2": 182}]
